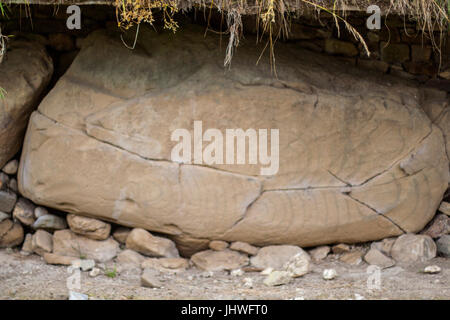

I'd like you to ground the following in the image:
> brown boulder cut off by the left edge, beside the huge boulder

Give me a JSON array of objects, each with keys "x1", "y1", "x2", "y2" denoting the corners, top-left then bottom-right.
[{"x1": 0, "y1": 39, "x2": 53, "y2": 167}]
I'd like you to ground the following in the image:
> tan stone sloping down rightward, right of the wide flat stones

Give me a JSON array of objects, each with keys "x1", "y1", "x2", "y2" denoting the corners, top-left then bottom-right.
[{"x1": 126, "y1": 228, "x2": 179, "y2": 258}]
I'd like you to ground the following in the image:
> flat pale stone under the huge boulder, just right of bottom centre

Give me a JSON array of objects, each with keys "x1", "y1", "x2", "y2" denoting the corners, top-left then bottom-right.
[{"x1": 250, "y1": 245, "x2": 304, "y2": 270}]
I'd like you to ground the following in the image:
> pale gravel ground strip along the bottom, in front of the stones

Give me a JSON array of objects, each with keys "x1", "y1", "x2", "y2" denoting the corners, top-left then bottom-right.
[{"x1": 0, "y1": 249, "x2": 450, "y2": 300}]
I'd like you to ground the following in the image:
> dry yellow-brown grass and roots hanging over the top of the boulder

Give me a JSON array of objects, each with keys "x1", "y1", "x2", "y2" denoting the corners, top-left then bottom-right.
[{"x1": 110, "y1": 0, "x2": 450, "y2": 67}]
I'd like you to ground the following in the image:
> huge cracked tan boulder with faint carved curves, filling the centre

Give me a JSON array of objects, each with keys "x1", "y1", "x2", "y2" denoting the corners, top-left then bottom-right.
[{"x1": 19, "y1": 28, "x2": 449, "y2": 249}]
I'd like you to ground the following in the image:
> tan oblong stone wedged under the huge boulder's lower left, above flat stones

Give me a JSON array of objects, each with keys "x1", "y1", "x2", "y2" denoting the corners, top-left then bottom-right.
[{"x1": 67, "y1": 214, "x2": 111, "y2": 240}]
